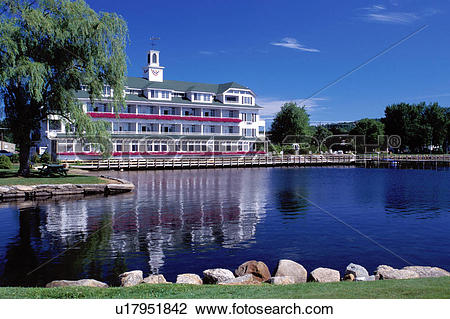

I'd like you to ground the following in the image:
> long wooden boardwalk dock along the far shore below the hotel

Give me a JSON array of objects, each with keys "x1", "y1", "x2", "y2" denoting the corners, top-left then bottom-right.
[{"x1": 66, "y1": 154, "x2": 450, "y2": 170}]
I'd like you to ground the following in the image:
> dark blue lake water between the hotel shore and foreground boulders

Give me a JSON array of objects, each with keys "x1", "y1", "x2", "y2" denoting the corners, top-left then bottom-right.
[{"x1": 0, "y1": 167, "x2": 450, "y2": 286}]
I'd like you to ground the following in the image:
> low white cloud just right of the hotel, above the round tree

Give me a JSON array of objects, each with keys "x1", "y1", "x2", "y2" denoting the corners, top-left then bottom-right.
[{"x1": 257, "y1": 97, "x2": 328, "y2": 119}]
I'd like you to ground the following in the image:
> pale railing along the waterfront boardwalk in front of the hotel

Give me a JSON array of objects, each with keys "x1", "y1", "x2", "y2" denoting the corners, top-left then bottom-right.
[{"x1": 68, "y1": 155, "x2": 355, "y2": 170}]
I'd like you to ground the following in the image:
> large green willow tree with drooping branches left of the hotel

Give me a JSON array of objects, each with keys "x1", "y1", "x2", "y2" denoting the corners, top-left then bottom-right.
[{"x1": 0, "y1": 0, "x2": 127, "y2": 176}]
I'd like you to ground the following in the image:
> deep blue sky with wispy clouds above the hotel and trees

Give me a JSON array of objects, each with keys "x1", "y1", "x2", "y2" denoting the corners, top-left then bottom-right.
[{"x1": 87, "y1": 0, "x2": 450, "y2": 122}]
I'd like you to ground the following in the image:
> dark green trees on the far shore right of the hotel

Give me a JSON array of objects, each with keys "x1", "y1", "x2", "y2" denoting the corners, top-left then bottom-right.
[{"x1": 269, "y1": 102, "x2": 450, "y2": 153}]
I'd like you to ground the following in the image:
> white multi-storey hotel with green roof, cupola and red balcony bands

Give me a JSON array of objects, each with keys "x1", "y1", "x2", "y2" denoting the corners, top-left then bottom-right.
[{"x1": 38, "y1": 50, "x2": 265, "y2": 160}]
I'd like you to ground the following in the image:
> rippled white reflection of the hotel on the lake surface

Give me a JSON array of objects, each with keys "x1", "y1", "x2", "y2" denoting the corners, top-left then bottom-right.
[{"x1": 21, "y1": 170, "x2": 267, "y2": 273}]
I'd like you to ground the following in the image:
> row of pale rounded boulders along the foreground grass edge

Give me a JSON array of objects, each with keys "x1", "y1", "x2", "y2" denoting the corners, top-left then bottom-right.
[{"x1": 46, "y1": 259, "x2": 450, "y2": 288}]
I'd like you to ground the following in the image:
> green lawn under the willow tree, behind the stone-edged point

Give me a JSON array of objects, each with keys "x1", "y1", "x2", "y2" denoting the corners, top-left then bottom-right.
[{"x1": 0, "y1": 165, "x2": 108, "y2": 185}]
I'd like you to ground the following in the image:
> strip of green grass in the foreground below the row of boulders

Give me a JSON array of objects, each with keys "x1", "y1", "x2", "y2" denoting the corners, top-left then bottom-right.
[{"x1": 0, "y1": 277, "x2": 450, "y2": 299}]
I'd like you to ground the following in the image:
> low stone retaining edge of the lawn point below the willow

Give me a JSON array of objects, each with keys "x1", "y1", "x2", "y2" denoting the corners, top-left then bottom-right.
[{"x1": 0, "y1": 175, "x2": 134, "y2": 202}]
